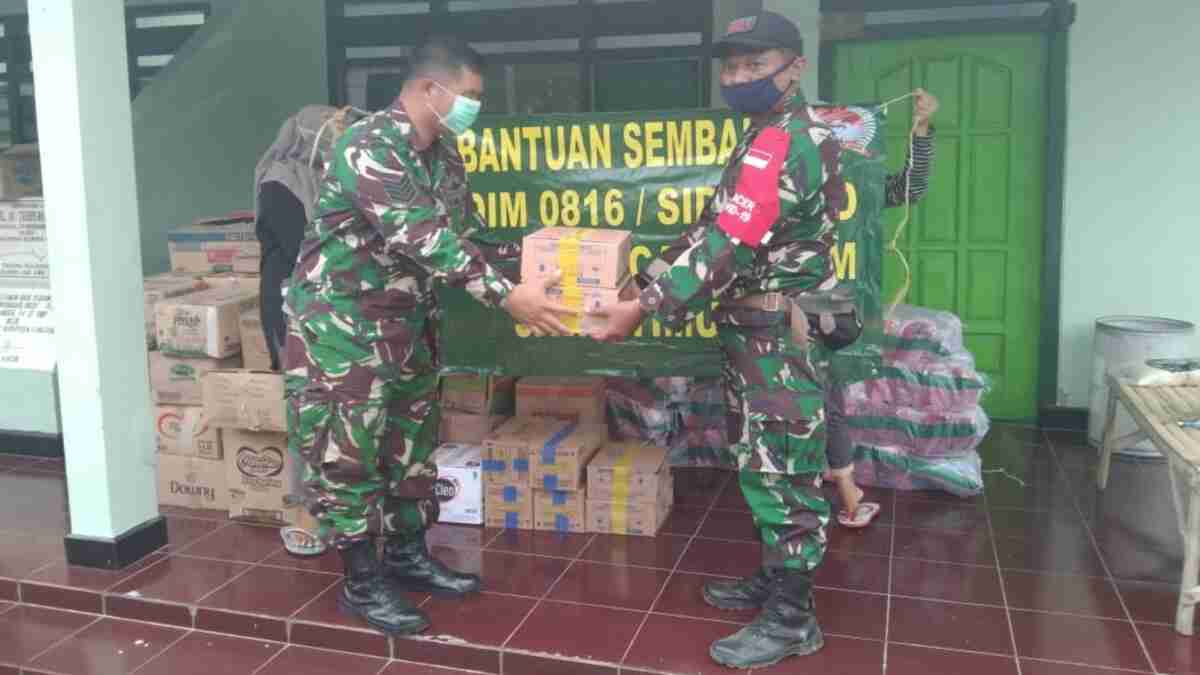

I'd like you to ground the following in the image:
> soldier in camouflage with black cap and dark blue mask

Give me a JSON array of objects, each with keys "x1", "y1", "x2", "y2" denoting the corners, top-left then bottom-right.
[{"x1": 593, "y1": 12, "x2": 847, "y2": 668}]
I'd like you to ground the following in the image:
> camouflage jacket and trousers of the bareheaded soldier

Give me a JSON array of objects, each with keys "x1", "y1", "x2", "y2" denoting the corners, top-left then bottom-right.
[{"x1": 284, "y1": 108, "x2": 512, "y2": 548}]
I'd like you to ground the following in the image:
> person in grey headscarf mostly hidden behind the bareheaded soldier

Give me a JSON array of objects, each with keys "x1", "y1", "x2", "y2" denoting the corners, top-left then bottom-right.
[{"x1": 254, "y1": 106, "x2": 361, "y2": 555}]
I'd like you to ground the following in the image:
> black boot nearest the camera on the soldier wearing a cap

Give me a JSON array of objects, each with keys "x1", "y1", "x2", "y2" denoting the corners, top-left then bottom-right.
[{"x1": 708, "y1": 571, "x2": 824, "y2": 668}]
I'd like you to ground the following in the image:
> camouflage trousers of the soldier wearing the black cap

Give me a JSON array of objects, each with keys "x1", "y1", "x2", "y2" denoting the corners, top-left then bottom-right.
[{"x1": 715, "y1": 307, "x2": 830, "y2": 572}]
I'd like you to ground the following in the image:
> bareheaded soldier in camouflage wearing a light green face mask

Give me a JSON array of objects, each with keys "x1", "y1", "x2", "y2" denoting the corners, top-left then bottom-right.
[{"x1": 284, "y1": 38, "x2": 569, "y2": 633}]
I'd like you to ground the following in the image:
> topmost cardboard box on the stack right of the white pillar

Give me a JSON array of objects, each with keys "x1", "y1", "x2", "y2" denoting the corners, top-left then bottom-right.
[{"x1": 167, "y1": 216, "x2": 263, "y2": 274}]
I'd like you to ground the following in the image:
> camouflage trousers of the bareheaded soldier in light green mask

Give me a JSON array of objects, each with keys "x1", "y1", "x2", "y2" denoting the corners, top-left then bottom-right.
[{"x1": 284, "y1": 307, "x2": 440, "y2": 548}]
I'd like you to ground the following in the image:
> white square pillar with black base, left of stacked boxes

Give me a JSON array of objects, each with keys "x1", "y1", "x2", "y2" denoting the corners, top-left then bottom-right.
[{"x1": 29, "y1": 0, "x2": 166, "y2": 567}]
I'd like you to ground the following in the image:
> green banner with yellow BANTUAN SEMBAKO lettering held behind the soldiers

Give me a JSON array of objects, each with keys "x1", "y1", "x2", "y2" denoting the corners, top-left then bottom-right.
[{"x1": 439, "y1": 106, "x2": 884, "y2": 377}]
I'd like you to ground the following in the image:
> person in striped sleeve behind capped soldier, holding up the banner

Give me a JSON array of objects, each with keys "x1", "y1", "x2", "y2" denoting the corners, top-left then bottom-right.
[{"x1": 825, "y1": 89, "x2": 938, "y2": 530}]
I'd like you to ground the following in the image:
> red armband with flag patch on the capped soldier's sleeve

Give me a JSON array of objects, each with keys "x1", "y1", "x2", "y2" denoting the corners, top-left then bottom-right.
[{"x1": 716, "y1": 126, "x2": 792, "y2": 249}]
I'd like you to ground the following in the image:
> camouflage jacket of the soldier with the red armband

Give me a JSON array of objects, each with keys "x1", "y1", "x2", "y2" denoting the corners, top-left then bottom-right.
[{"x1": 641, "y1": 94, "x2": 846, "y2": 327}]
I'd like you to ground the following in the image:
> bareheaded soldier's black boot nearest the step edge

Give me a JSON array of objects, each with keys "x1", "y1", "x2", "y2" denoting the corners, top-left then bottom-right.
[{"x1": 337, "y1": 542, "x2": 430, "y2": 635}]
